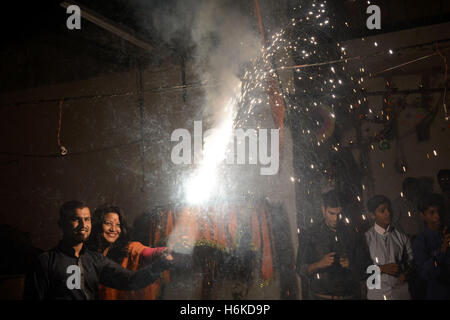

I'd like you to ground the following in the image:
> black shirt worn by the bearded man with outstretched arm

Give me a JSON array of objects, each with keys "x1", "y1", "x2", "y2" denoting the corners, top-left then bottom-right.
[{"x1": 24, "y1": 243, "x2": 167, "y2": 300}]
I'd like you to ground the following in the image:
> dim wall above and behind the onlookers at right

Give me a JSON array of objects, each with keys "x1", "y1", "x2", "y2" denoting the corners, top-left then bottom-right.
[{"x1": 343, "y1": 24, "x2": 450, "y2": 208}]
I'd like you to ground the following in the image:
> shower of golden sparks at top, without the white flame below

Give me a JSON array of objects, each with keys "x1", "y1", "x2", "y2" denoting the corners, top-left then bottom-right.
[{"x1": 235, "y1": 1, "x2": 367, "y2": 144}]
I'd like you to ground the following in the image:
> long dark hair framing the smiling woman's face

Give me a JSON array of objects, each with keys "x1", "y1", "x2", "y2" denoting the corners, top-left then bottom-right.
[{"x1": 88, "y1": 204, "x2": 130, "y2": 264}]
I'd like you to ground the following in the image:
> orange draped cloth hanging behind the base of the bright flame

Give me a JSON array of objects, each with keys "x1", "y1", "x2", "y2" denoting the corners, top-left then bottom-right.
[{"x1": 147, "y1": 205, "x2": 275, "y2": 282}]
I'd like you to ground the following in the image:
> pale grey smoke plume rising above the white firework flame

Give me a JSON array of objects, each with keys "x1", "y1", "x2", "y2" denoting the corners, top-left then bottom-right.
[{"x1": 152, "y1": 0, "x2": 261, "y2": 126}]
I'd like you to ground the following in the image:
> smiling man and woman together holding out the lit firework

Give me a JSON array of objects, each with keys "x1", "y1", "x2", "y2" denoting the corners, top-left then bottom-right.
[{"x1": 24, "y1": 201, "x2": 174, "y2": 300}]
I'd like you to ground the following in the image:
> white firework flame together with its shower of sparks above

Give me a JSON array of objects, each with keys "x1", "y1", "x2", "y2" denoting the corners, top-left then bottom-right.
[{"x1": 185, "y1": 1, "x2": 367, "y2": 203}]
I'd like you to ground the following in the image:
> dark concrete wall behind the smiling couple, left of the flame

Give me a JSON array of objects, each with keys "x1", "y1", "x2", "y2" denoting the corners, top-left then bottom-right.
[{"x1": 0, "y1": 61, "x2": 189, "y2": 249}]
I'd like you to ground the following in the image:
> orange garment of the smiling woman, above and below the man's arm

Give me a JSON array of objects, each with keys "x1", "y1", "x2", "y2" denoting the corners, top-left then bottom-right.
[{"x1": 99, "y1": 242, "x2": 161, "y2": 300}]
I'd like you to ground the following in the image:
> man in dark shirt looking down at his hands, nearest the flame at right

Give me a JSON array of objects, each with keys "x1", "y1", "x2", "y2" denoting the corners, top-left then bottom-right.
[{"x1": 297, "y1": 190, "x2": 372, "y2": 300}]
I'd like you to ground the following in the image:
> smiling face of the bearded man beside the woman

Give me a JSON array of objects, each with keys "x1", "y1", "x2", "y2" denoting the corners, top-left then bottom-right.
[{"x1": 62, "y1": 207, "x2": 91, "y2": 243}]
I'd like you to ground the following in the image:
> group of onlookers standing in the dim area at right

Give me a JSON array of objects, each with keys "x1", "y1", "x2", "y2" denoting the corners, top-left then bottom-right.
[{"x1": 297, "y1": 170, "x2": 450, "y2": 300}]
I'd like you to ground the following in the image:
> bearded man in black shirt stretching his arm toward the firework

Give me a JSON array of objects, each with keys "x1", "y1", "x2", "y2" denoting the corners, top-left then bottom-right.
[{"x1": 24, "y1": 201, "x2": 172, "y2": 300}]
